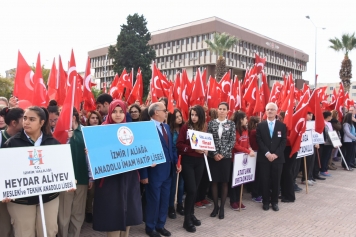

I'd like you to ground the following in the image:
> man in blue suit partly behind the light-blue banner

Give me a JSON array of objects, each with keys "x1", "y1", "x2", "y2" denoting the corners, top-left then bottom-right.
[{"x1": 140, "y1": 102, "x2": 180, "y2": 237}]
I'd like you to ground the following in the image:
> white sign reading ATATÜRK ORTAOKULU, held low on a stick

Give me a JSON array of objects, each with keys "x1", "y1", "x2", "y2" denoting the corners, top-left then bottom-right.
[{"x1": 232, "y1": 152, "x2": 257, "y2": 187}]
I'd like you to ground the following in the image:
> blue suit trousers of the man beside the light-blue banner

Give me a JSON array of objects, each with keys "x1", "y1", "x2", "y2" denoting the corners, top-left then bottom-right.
[{"x1": 145, "y1": 176, "x2": 172, "y2": 233}]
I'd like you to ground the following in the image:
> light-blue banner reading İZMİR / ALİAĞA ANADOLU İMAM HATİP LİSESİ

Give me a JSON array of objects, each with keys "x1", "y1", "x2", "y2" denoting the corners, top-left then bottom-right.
[{"x1": 82, "y1": 121, "x2": 166, "y2": 179}]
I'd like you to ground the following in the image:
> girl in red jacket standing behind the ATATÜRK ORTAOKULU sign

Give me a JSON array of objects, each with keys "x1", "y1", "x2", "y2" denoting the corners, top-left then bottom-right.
[{"x1": 229, "y1": 111, "x2": 255, "y2": 211}]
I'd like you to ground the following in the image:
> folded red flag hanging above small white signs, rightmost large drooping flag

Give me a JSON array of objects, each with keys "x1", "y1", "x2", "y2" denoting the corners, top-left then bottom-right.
[{"x1": 308, "y1": 88, "x2": 325, "y2": 133}]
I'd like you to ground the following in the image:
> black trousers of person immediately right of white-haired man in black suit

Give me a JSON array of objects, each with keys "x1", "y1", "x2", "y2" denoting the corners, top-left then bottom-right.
[{"x1": 281, "y1": 146, "x2": 297, "y2": 201}]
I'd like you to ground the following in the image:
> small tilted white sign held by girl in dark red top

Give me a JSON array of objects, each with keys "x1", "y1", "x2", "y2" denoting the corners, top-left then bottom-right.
[{"x1": 188, "y1": 129, "x2": 215, "y2": 151}]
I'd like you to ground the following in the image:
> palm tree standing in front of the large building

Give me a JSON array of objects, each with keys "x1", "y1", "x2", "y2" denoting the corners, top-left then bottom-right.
[{"x1": 205, "y1": 32, "x2": 239, "y2": 82}]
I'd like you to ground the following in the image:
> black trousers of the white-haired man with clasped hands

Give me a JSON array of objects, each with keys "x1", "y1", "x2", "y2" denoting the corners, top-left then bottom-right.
[{"x1": 258, "y1": 162, "x2": 283, "y2": 204}]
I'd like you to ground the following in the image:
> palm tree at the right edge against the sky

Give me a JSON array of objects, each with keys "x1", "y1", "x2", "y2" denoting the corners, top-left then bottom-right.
[{"x1": 329, "y1": 33, "x2": 356, "y2": 92}]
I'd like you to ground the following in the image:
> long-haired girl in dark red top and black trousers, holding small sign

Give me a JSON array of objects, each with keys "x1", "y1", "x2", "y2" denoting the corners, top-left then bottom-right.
[{"x1": 177, "y1": 105, "x2": 207, "y2": 232}]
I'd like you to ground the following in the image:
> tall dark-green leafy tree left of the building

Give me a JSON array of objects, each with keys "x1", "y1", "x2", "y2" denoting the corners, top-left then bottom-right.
[{"x1": 109, "y1": 13, "x2": 156, "y2": 94}]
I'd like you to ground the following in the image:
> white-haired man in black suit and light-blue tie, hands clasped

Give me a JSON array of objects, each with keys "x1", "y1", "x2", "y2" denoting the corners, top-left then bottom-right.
[{"x1": 256, "y1": 103, "x2": 287, "y2": 211}]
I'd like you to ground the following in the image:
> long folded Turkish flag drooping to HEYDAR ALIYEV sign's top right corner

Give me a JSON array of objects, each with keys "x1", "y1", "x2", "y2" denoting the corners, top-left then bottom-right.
[{"x1": 53, "y1": 50, "x2": 78, "y2": 144}]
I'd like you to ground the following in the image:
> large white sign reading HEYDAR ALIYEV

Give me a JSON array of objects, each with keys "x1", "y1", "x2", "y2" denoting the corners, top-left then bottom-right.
[{"x1": 0, "y1": 144, "x2": 76, "y2": 200}]
